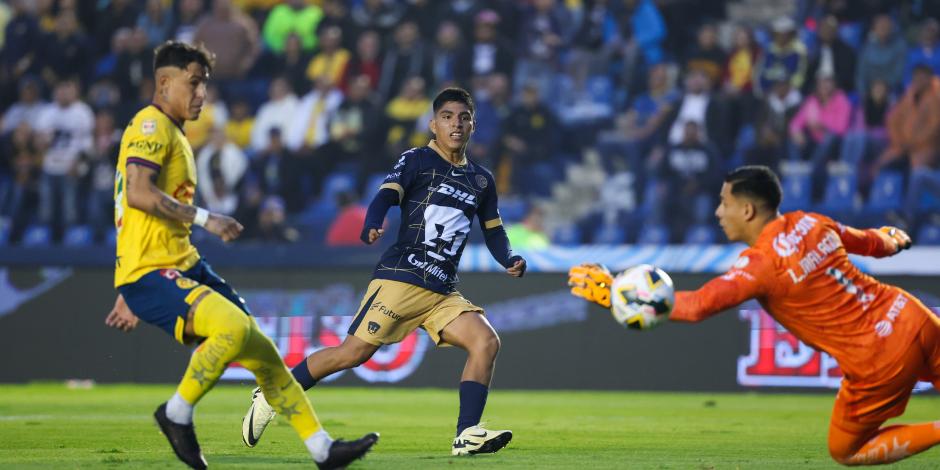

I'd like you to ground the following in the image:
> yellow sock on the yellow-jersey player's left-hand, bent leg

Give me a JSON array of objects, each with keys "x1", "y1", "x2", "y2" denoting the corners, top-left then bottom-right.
[{"x1": 176, "y1": 288, "x2": 252, "y2": 405}]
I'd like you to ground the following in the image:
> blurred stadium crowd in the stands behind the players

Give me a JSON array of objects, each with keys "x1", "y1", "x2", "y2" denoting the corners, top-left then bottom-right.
[{"x1": 0, "y1": 0, "x2": 940, "y2": 246}]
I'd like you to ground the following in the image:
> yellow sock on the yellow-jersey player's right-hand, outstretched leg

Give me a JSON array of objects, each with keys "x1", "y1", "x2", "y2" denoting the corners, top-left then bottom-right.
[{"x1": 236, "y1": 317, "x2": 322, "y2": 441}]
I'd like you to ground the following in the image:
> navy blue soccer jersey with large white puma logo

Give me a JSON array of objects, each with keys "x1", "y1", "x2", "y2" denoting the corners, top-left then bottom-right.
[{"x1": 372, "y1": 146, "x2": 502, "y2": 294}]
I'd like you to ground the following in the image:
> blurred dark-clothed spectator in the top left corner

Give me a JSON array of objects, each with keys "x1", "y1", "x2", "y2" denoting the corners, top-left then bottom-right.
[{"x1": 0, "y1": 0, "x2": 40, "y2": 92}]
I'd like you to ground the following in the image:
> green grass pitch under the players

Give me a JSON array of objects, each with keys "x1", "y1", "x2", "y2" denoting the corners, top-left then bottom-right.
[{"x1": 0, "y1": 384, "x2": 940, "y2": 470}]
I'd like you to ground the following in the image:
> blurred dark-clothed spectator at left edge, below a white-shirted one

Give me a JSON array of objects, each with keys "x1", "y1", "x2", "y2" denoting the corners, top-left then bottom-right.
[{"x1": 0, "y1": 122, "x2": 42, "y2": 241}]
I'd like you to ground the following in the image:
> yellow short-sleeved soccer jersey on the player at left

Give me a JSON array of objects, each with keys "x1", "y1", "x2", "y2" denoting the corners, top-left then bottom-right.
[{"x1": 114, "y1": 105, "x2": 199, "y2": 287}]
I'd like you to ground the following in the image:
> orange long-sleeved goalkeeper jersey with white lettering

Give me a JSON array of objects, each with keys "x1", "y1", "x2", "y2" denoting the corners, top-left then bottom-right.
[{"x1": 670, "y1": 211, "x2": 930, "y2": 380}]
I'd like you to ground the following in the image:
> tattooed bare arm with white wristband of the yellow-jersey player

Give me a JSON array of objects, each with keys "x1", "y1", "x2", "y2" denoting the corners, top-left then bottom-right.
[{"x1": 127, "y1": 163, "x2": 244, "y2": 242}]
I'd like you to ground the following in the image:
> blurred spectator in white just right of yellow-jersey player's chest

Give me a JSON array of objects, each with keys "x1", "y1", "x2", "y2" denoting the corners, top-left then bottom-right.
[{"x1": 196, "y1": 129, "x2": 248, "y2": 215}]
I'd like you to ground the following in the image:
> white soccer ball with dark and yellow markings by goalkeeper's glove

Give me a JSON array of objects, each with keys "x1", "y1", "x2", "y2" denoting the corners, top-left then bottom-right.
[{"x1": 610, "y1": 264, "x2": 676, "y2": 330}]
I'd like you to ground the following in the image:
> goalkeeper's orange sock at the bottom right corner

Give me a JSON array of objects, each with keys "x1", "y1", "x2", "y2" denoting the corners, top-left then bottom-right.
[{"x1": 843, "y1": 421, "x2": 940, "y2": 465}]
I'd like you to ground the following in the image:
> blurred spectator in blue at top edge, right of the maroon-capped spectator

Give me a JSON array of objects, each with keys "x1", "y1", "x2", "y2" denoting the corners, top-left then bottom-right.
[{"x1": 513, "y1": 0, "x2": 566, "y2": 96}]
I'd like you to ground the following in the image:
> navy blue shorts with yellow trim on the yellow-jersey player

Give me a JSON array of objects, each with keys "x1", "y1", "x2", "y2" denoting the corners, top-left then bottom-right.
[{"x1": 118, "y1": 259, "x2": 251, "y2": 343}]
